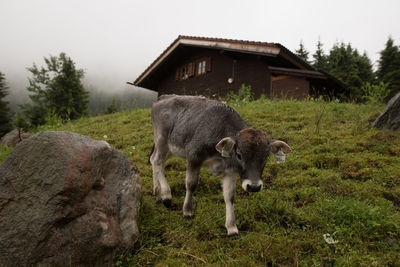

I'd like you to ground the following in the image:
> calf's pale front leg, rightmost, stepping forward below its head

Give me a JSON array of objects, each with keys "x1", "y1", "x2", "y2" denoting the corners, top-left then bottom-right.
[{"x1": 222, "y1": 174, "x2": 239, "y2": 236}]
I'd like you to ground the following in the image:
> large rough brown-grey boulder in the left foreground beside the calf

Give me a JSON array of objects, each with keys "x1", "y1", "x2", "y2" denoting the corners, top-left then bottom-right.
[{"x1": 0, "y1": 132, "x2": 141, "y2": 266}]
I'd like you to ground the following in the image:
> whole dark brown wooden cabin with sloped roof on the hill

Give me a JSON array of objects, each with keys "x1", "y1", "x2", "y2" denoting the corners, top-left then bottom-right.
[{"x1": 133, "y1": 36, "x2": 343, "y2": 99}]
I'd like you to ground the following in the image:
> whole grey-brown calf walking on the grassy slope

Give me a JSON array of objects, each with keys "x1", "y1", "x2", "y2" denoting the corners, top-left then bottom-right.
[{"x1": 150, "y1": 95, "x2": 291, "y2": 235}]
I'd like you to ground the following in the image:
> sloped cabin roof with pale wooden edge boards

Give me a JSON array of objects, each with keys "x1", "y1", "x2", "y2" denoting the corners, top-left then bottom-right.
[{"x1": 133, "y1": 35, "x2": 316, "y2": 86}]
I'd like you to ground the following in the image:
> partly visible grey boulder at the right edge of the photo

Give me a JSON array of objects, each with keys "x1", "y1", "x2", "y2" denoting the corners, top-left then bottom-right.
[{"x1": 372, "y1": 92, "x2": 400, "y2": 131}]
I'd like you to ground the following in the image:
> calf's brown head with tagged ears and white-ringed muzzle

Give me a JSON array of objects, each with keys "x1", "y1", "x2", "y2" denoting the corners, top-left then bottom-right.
[{"x1": 215, "y1": 128, "x2": 291, "y2": 192}]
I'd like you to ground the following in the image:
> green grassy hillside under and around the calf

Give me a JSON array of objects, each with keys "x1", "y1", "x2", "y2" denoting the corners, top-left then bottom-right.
[{"x1": 0, "y1": 101, "x2": 400, "y2": 266}]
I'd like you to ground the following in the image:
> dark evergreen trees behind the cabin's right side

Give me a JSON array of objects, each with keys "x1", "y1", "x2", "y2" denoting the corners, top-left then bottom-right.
[{"x1": 295, "y1": 37, "x2": 400, "y2": 102}]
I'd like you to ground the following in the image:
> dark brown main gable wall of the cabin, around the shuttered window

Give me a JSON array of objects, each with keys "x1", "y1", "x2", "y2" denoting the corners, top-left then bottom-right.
[{"x1": 157, "y1": 48, "x2": 271, "y2": 98}]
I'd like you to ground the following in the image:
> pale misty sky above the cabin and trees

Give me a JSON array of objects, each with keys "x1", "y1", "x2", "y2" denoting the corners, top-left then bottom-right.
[{"x1": 0, "y1": 0, "x2": 400, "y2": 103}]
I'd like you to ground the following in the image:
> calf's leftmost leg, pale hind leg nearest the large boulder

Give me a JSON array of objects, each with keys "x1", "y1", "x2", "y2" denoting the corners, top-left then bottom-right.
[{"x1": 150, "y1": 142, "x2": 172, "y2": 207}]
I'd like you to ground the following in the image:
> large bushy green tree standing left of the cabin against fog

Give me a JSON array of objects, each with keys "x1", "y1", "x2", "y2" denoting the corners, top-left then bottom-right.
[{"x1": 26, "y1": 53, "x2": 89, "y2": 125}]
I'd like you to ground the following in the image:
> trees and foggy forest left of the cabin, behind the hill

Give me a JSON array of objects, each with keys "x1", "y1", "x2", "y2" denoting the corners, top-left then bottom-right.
[{"x1": 0, "y1": 53, "x2": 155, "y2": 137}]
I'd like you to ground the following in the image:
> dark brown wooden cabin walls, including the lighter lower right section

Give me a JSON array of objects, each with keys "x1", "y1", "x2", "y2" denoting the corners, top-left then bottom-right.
[{"x1": 153, "y1": 47, "x2": 310, "y2": 99}]
